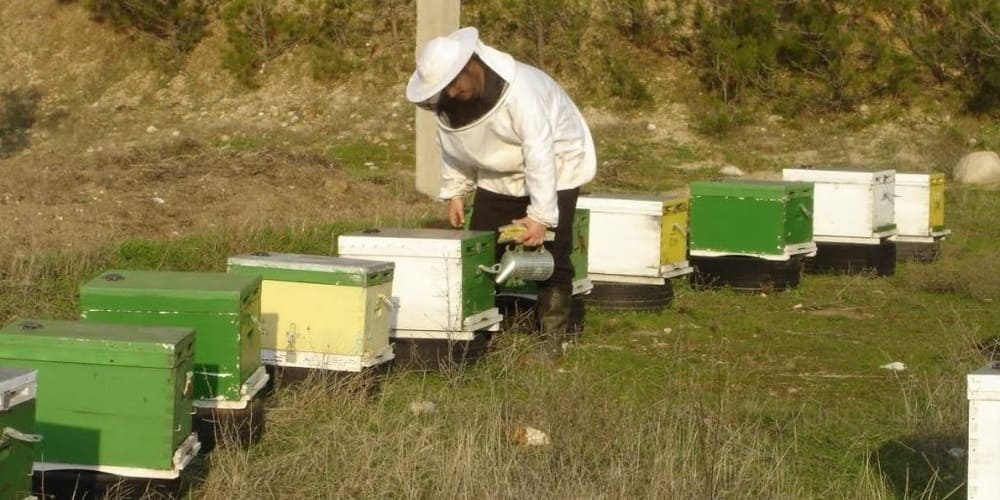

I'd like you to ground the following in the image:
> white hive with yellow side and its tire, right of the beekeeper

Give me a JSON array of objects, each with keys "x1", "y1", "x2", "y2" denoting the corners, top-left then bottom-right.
[{"x1": 577, "y1": 194, "x2": 692, "y2": 310}]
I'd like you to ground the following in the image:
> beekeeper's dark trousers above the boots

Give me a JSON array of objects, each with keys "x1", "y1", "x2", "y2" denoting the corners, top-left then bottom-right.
[{"x1": 469, "y1": 188, "x2": 580, "y2": 287}]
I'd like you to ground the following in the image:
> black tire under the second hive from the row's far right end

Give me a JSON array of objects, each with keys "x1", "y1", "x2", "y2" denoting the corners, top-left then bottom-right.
[{"x1": 805, "y1": 240, "x2": 896, "y2": 276}]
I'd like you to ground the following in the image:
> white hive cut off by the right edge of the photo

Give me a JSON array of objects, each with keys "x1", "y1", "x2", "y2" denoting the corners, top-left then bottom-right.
[{"x1": 967, "y1": 362, "x2": 1000, "y2": 500}]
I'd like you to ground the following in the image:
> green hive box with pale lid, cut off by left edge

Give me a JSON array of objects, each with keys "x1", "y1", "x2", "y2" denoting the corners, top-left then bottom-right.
[{"x1": 0, "y1": 367, "x2": 37, "y2": 500}]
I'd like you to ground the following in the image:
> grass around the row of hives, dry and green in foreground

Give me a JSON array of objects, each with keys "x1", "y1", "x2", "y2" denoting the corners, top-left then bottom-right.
[{"x1": 0, "y1": 185, "x2": 1000, "y2": 499}]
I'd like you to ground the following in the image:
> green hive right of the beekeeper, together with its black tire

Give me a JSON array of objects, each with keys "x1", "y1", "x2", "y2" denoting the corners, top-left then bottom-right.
[{"x1": 688, "y1": 180, "x2": 816, "y2": 291}]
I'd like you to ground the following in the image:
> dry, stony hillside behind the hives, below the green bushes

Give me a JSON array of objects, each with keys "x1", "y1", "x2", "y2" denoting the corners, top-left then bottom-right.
[{"x1": 0, "y1": 0, "x2": 979, "y2": 266}]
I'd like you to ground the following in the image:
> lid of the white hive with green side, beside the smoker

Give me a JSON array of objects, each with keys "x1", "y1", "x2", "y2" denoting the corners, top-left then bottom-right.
[{"x1": 337, "y1": 229, "x2": 496, "y2": 258}]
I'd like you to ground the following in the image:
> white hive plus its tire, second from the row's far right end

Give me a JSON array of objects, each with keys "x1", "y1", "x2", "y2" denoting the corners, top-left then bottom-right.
[{"x1": 782, "y1": 167, "x2": 897, "y2": 276}]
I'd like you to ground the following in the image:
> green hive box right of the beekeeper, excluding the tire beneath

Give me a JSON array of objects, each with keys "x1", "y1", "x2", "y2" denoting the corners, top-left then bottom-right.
[{"x1": 688, "y1": 180, "x2": 816, "y2": 260}]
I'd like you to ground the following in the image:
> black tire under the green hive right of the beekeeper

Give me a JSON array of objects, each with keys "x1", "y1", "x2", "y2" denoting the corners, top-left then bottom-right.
[{"x1": 689, "y1": 255, "x2": 802, "y2": 292}]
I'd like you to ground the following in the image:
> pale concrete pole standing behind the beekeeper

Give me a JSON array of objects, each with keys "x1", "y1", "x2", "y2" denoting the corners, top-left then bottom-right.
[{"x1": 415, "y1": 0, "x2": 461, "y2": 198}]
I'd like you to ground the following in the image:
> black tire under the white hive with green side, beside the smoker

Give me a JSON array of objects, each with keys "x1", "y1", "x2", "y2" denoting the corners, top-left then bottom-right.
[{"x1": 393, "y1": 332, "x2": 492, "y2": 371}]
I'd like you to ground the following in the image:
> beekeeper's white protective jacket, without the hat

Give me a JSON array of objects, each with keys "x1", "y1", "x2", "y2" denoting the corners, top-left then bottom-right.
[{"x1": 438, "y1": 42, "x2": 597, "y2": 227}]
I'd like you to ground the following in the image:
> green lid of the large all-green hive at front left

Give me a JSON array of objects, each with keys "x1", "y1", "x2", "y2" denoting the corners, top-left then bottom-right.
[{"x1": 0, "y1": 318, "x2": 194, "y2": 367}]
